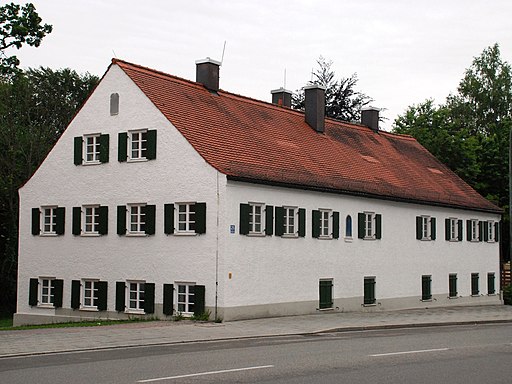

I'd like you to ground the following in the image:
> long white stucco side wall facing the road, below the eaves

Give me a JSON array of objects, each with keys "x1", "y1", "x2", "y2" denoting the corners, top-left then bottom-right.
[{"x1": 222, "y1": 182, "x2": 500, "y2": 316}]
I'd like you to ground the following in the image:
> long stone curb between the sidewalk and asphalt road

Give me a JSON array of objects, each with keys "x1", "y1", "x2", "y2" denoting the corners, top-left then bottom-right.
[{"x1": 0, "y1": 319, "x2": 512, "y2": 360}]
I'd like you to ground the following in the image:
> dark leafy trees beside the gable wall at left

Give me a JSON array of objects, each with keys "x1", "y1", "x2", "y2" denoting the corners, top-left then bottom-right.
[{"x1": 0, "y1": 68, "x2": 98, "y2": 312}]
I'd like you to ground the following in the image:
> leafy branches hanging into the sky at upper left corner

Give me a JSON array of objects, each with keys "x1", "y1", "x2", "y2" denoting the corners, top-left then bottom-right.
[{"x1": 0, "y1": 3, "x2": 52, "y2": 76}]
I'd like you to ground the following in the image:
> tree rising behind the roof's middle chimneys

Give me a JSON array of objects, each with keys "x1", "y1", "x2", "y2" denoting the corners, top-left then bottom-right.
[{"x1": 292, "y1": 56, "x2": 373, "y2": 121}]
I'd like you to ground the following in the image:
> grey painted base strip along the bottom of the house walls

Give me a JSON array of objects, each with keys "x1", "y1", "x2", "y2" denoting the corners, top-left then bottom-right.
[{"x1": 13, "y1": 294, "x2": 503, "y2": 326}]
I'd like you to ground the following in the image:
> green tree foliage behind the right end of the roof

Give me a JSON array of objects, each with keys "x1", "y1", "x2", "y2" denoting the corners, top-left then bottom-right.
[{"x1": 393, "y1": 44, "x2": 512, "y2": 260}]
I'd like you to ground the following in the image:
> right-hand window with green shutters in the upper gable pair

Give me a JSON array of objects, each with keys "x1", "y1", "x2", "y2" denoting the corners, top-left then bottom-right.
[{"x1": 118, "y1": 129, "x2": 156, "y2": 162}]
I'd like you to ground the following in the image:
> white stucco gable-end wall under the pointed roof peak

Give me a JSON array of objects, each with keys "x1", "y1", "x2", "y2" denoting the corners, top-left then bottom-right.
[{"x1": 17, "y1": 65, "x2": 225, "y2": 320}]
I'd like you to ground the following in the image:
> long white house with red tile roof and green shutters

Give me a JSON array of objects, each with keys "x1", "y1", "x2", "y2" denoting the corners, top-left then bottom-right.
[{"x1": 15, "y1": 59, "x2": 501, "y2": 324}]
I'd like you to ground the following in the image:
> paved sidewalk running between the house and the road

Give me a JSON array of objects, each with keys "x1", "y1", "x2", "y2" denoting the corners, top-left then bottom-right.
[{"x1": 0, "y1": 305, "x2": 512, "y2": 358}]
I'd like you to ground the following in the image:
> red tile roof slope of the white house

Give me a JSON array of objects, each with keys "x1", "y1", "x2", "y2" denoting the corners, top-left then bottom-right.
[{"x1": 113, "y1": 60, "x2": 501, "y2": 213}]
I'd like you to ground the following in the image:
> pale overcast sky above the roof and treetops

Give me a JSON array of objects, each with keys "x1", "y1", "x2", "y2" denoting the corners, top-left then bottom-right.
[{"x1": 7, "y1": 0, "x2": 512, "y2": 129}]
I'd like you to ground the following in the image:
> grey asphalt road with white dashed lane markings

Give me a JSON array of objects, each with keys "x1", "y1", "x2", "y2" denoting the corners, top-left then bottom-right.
[{"x1": 0, "y1": 324, "x2": 512, "y2": 384}]
